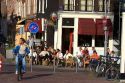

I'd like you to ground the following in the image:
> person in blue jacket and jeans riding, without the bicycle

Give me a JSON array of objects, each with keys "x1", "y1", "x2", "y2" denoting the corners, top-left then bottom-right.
[{"x1": 13, "y1": 38, "x2": 30, "y2": 74}]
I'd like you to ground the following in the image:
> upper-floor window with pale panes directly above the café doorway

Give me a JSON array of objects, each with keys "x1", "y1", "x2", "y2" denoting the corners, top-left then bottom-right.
[{"x1": 64, "y1": 0, "x2": 75, "y2": 10}]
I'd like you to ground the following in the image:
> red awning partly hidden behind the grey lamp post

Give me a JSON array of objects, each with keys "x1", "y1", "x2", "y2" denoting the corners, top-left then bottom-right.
[{"x1": 96, "y1": 19, "x2": 113, "y2": 36}]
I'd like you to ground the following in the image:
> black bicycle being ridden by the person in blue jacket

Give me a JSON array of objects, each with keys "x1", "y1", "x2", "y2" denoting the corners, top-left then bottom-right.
[{"x1": 17, "y1": 56, "x2": 24, "y2": 81}]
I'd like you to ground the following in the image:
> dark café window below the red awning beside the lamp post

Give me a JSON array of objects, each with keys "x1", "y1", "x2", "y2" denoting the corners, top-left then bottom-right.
[{"x1": 95, "y1": 36, "x2": 105, "y2": 47}]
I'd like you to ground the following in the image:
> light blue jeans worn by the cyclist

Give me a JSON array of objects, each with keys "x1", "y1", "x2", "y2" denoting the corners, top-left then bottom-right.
[{"x1": 15, "y1": 54, "x2": 26, "y2": 72}]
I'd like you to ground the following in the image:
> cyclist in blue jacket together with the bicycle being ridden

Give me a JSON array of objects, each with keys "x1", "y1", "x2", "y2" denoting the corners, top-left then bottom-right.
[{"x1": 13, "y1": 38, "x2": 30, "y2": 80}]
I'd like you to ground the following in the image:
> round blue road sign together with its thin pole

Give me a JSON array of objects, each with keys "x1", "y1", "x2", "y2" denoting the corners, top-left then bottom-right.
[{"x1": 28, "y1": 22, "x2": 39, "y2": 72}]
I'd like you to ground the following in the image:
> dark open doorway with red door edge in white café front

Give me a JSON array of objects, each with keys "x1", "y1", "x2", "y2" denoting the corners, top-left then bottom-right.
[{"x1": 62, "y1": 28, "x2": 74, "y2": 54}]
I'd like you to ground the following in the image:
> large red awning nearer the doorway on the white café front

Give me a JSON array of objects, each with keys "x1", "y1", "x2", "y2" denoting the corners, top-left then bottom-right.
[{"x1": 78, "y1": 18, "x2": 96, "y2": 35}]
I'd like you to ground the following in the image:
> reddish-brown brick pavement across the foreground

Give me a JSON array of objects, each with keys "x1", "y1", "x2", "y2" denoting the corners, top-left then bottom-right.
[{"x1": 0, "y1": 65, "x2": 117, "y2": 83}]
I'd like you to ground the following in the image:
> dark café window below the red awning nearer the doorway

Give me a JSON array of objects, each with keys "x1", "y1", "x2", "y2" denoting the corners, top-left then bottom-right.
[{"x1": 78, "y1": 35, "x2": 92, "y2": 47}]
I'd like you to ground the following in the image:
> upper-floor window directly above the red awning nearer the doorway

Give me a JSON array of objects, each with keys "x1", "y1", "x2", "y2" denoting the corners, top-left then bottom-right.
[{"x1": 81, "y1": 0, "x2": 93, "y2": 11}]
